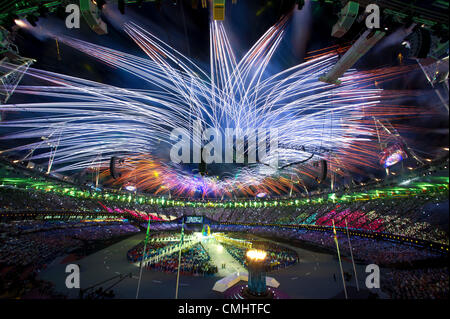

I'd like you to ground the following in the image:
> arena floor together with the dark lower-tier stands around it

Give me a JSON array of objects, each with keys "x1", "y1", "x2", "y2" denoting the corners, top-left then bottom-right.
[{"x1": 0, "y1": 220, "x2": 449, "y2": 299}]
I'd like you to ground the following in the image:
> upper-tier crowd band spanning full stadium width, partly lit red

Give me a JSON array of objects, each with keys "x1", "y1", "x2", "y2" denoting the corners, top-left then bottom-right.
[{"x1": 0, "y1": 179, "x2": 449, "y2": 244}]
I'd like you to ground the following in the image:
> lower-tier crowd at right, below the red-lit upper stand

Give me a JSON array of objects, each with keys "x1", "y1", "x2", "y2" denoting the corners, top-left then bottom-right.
[{"x1": 215, "y1": 226, "x2": 449, "y2": 299}]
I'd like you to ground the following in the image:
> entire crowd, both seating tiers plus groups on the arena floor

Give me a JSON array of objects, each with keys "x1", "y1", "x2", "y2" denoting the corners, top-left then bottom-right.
[{"x1": 0, "y1": 162, "x2": 449, "y2": 299}]
